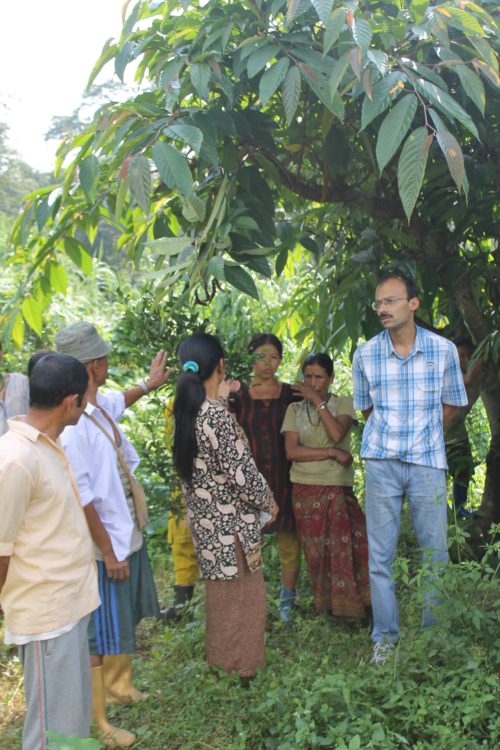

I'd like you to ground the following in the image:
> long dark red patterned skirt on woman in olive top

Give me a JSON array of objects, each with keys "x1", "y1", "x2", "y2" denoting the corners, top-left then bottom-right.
[{"x1": 292, "y1": 484, "x2": 370, "y2": 618}]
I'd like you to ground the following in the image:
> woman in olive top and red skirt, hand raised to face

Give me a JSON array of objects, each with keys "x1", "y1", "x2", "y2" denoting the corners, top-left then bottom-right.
[{"x1": 282, "y1": 354, "x2": 370, "y2": 619}]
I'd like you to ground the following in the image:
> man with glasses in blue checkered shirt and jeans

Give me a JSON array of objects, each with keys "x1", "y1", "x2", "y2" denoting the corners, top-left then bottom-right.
[{"x1": 353, "y1": 272, "x2": 467, "y2": 665}]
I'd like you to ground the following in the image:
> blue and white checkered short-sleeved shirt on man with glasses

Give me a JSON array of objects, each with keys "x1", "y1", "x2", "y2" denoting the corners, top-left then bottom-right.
[{"x1": 352, "y1": 326, "x2": 467, "y2": 469}]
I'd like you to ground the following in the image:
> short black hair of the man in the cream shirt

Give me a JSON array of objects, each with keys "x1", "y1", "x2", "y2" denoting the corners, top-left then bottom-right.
[{"x1": 30, "y1": 352, "x2": 89, "y2": 409}]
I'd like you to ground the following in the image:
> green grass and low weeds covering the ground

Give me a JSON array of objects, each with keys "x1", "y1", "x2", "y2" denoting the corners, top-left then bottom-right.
[{"x1": 0, "y1": 516, "x2": 500, "y2": 750}]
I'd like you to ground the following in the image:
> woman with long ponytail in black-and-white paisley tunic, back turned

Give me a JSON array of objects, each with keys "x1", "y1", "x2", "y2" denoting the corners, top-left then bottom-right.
[{"x1": 174, "y1": 333, "x2": 277, "y2": 678}]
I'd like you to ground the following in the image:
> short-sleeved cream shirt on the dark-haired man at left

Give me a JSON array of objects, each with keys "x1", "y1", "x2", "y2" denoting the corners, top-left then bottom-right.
[{"x1": 0, "y1": 419, "x2": 100, "y2": 635}]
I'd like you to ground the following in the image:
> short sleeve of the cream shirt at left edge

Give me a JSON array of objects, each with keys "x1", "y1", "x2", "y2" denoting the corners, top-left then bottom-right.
[{"x1": 0, "y1": 461, "x2": 33, "y2": 557}]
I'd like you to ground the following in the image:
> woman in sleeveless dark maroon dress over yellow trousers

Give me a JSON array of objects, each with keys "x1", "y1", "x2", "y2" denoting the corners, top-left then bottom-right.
[{"x1": 234, "y1": 333, "x2": 300, "y2": 622}]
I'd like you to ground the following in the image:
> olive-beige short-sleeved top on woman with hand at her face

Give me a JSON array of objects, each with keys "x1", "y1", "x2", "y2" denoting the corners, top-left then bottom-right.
[{"x1": 281, "y1": 395, "x2": 356, "y2": 487}]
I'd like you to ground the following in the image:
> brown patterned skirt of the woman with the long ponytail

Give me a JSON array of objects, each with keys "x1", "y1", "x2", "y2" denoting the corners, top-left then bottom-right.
[{"x1": 205, "y1": 538, "x2": 266, "y2": 677}]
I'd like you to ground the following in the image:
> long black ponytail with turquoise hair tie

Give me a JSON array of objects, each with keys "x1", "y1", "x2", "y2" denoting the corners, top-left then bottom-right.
[{"x1": 173, "y1": 333, "x2": 224, "y2": 482}]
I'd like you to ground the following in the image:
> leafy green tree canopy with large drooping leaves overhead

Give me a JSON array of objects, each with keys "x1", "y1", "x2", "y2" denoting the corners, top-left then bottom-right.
[{"x1": 4, "y1": 0, "x2": 500, "y2": 340}]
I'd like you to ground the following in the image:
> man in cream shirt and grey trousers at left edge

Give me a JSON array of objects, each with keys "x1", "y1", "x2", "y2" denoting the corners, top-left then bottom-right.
[{"x1": 0, "y1": 354, "x2": 100, "y2": 750}]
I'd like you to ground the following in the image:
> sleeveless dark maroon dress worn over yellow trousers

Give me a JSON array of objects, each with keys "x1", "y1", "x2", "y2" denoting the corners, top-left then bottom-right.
[{"x1": 231, "y1": 383, "x2": 301, "y2": 533}]
